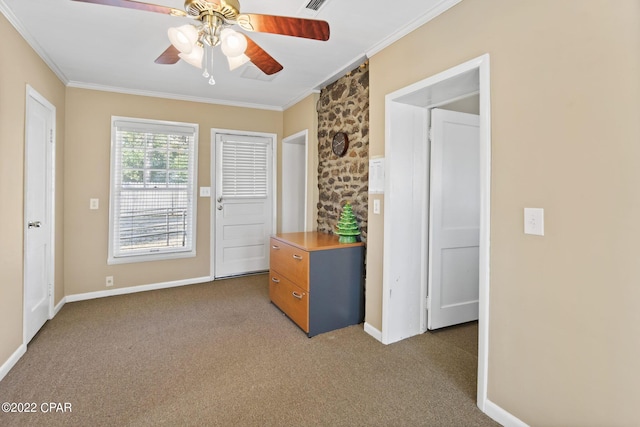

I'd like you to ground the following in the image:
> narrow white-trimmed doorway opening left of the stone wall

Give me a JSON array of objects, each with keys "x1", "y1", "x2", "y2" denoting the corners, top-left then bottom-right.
[{"x1": 282, "y1": 130, "x2": 309, "y2": 233}]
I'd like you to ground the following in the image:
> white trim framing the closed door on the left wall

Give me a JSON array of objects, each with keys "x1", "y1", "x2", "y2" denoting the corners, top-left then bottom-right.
[{"x1": 22, "y1": 85, "x2": 56, "y2": 345}]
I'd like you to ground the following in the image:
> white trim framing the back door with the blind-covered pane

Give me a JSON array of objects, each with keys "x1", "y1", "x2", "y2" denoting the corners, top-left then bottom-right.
[{"x1": 209, "y1": 128, "x2": 278, "y2": 280}]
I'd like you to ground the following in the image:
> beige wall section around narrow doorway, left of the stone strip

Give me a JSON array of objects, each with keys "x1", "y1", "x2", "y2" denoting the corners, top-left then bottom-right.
[{"x1": 278, "y1": 93, "x2": 320, "y2": 231}]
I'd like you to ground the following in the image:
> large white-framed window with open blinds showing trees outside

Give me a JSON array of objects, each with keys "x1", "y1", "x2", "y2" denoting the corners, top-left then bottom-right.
[{"x1": 108, "y1": 117, "x2": 198, "y2": 264}]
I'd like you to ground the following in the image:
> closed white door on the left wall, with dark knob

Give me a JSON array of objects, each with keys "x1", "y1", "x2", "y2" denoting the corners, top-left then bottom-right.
[{"x1": 24, "y1": 88, "x2": 55, "y2": 344}]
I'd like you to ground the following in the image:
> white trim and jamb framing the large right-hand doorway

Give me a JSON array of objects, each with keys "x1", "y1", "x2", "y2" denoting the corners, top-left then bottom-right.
[{"x1": 381, "y1": 54, "x2": 491, "y2": 412}]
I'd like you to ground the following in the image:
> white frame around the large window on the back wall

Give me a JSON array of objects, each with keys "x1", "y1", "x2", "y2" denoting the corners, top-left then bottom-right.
[{"x1": 107, "y1": 116, "x2": 199, "y2": 265}]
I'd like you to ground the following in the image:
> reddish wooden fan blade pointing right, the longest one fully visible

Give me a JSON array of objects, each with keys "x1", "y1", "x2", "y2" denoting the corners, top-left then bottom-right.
[{"x1": 238, "y1": 13, "x2": 329, "y2": 41}]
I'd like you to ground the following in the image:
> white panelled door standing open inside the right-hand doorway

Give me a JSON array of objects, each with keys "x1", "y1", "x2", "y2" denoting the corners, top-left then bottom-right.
[{"x1": 427, "y1": 109, "x2": 480, "y2": 329}]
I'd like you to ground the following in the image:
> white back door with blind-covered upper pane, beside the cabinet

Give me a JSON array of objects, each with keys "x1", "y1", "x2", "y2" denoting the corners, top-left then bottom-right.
[{"x1": 215, "y1": 134, "x2": 273, "y2": 278}]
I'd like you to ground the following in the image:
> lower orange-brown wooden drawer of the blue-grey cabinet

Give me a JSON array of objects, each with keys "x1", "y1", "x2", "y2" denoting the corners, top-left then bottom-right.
[{"x1": 269, "y1": 270, "x2": 309, "y2": 333}]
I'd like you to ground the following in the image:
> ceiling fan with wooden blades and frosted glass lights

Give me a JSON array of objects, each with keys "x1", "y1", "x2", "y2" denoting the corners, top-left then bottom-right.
[{"x1": 73, "y1": 0, "x2": 329, "y2": 84}]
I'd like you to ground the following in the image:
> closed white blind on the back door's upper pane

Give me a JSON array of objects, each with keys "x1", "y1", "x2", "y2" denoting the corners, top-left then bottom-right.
[{"x1": 222, "y1": 140, "x2": 269, "y2": 199}]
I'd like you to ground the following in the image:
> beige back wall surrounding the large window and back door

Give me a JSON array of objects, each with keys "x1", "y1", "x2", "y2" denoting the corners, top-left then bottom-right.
[{"x1": 64, "y1": 88, "x2": 282, "y2": 295}]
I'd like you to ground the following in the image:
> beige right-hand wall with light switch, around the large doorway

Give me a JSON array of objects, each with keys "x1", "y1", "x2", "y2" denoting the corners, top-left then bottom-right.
[{"x1": 367, "y1": 0, "x2": 640, "y2": 426}]
